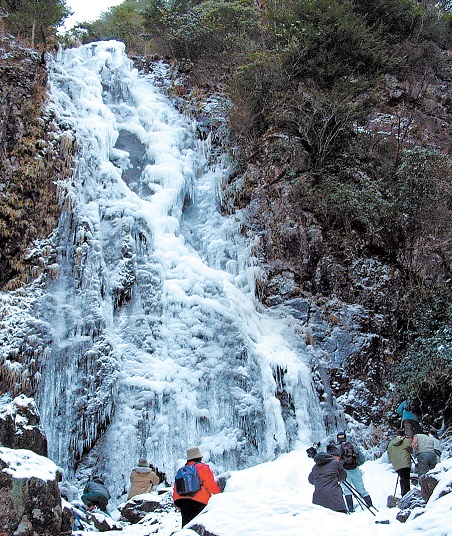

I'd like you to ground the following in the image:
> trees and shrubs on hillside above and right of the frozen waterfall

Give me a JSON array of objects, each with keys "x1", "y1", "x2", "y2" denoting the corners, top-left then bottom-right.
[{"x1": 0, "y1": 0, "x2": 452, "y2": 432}]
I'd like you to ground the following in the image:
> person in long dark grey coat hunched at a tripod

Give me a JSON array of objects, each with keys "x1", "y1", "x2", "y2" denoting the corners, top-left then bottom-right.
[{"x1": 308, "y1": 448, "x2": 348, "y2": 514}]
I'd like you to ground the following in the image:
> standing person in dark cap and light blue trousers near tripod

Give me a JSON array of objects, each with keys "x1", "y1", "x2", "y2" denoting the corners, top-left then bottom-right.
[{"x1": 334, "y1": 432, "x2": 373, "y2": 513}]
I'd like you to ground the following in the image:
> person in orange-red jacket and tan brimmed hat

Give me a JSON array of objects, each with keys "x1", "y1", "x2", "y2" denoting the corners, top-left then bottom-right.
[{"x1": 173, "y1": 447, "x2": 221, "y2": 527}]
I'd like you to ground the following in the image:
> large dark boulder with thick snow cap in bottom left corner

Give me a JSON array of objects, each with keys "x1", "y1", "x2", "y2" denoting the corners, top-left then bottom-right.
[{"x1": 0, "y1": 447, "x2": 63, "y2": 536}]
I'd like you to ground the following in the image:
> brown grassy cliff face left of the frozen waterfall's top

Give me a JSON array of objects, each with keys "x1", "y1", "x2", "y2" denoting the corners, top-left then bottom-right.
[{"x1": 0, "y1": 36, "x2": 75, "y2": 289}]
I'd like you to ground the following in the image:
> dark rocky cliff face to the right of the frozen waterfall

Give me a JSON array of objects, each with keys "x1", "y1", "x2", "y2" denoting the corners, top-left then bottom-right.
[{"x1": 219, "y1": 53, "x2": 452, "y2": 432}]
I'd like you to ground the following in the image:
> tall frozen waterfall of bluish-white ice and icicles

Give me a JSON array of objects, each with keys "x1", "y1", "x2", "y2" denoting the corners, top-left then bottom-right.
[{"x1": 30, "y1": 41, "x2": 322, "y2": 497}]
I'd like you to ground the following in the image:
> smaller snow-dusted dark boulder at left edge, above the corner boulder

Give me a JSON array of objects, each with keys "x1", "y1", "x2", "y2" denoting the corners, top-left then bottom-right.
[{"x1": 0, "y1": 395, "x2": 47, "y2": 456}]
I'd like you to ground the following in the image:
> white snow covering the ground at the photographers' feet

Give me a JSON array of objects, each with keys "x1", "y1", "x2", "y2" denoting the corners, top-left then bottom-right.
[{"x1": 77, "y1": 450, "x2": 452, "y2": 536}]
